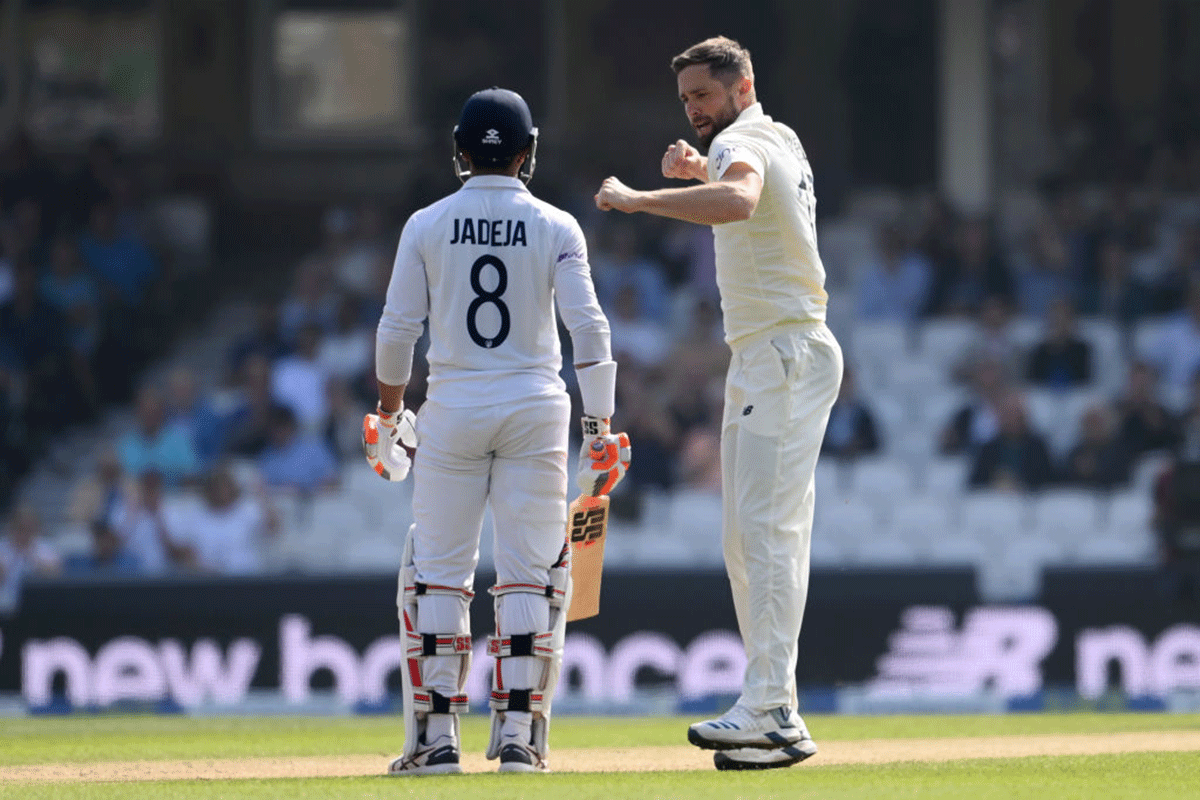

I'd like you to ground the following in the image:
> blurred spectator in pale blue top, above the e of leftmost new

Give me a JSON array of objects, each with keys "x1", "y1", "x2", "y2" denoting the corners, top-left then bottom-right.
[{"x1": 112, "y1": 468, "x2": 196, "y2": 576}]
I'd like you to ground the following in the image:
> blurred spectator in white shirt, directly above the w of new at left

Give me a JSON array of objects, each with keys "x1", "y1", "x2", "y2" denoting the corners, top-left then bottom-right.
[{"x1": 171, "y1": 465, "x2": 278, "y2": 575}]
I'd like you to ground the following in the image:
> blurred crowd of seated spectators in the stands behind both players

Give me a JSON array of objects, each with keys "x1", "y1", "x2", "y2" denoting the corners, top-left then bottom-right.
[{"x1": 0, "y1": 125, "x2": 1200, "y2": 597}]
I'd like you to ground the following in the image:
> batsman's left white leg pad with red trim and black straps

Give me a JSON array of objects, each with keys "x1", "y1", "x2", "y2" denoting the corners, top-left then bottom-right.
[{"x1": 396, "y1": 530, "x2": 472, "y2": 758}]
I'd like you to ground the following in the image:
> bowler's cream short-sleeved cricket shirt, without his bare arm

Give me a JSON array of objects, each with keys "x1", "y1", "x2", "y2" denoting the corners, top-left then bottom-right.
[{"x1": 708, "y1": 103, "x2": 828, "y2": 344}]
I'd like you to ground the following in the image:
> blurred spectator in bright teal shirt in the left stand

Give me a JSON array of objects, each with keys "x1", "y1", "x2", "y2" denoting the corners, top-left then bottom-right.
[{"x1": 118, "y1": 385, "x2": 199, "y2": 486}]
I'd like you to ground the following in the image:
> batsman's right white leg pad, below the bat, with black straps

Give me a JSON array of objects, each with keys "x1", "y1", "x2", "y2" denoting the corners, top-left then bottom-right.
[{"x1": 487, "y1": 545, "x2": 571, "y2": 759}]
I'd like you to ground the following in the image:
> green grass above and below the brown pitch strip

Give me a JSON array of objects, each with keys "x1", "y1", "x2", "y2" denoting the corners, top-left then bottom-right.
[{"x1": 0, "y1": 714, "x2": 1200, "y2": 800}]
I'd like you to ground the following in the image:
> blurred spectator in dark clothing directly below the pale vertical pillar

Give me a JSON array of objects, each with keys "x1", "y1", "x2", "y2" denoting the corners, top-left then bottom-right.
[{"x1": 930, "y1": 219, "x2": 1013, "y2": 315}]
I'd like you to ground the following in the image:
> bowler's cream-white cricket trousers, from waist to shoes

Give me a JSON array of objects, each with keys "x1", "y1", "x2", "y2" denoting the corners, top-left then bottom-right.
[{"x1": 721, "y1": 323, "x2": 842, "y2": 711}]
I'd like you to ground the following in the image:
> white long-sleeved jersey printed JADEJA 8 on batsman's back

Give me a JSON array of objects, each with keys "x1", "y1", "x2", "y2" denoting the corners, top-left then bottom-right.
[{"x1": 377, "y1": 175, "x2": 611, "y2": 407}]
